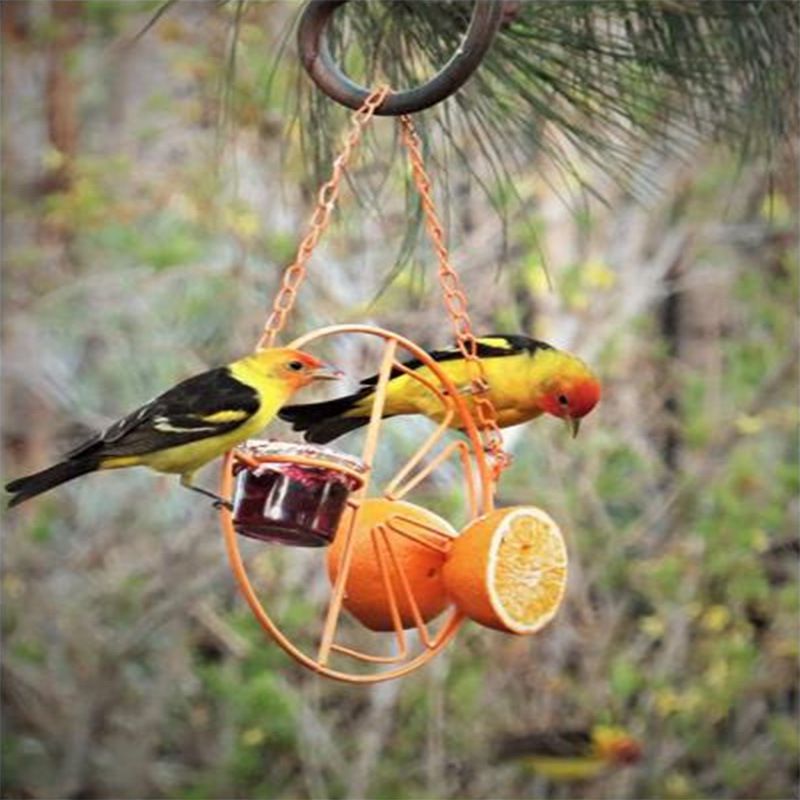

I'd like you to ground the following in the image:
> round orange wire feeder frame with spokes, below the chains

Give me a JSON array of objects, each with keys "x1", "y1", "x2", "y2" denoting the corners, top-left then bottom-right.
[{"x1": 220, "y1": 325, "x2": 493, "y2": 683}]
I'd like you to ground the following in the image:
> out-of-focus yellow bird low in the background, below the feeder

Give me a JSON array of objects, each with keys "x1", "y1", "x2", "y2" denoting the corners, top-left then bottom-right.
[{"x1": 496, "y1": 725, "x2": 642, "y2": 782}]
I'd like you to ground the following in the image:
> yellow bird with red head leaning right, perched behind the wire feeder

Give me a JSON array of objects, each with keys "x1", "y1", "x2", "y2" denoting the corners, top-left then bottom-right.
[{"x1": 279, "y1": 334, "x2": 600, "y2": 444}]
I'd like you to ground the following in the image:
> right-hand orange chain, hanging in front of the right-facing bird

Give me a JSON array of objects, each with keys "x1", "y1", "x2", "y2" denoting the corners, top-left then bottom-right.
[{"x1": 399, "y1": 114, "x2": 511, "y2": 480}]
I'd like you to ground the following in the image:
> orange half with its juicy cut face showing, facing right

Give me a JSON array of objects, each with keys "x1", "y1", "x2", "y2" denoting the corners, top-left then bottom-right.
[{"x1": 443, "y1": 506, "x2": 567, "y2": 633}]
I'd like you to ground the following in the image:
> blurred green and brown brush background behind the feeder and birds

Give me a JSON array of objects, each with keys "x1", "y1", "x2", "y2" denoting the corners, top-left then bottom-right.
[{"x1": 2, "y1": 0, "x2": 800, "y2": 798}]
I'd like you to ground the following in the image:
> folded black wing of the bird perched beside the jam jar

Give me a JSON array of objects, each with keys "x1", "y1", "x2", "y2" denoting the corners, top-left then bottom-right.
[{"x1": 67, "y1": 367, "x2": 260, "y2": 459}]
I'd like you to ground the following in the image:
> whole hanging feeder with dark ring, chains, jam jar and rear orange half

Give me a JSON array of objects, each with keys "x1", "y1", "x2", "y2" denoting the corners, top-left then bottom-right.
[{"x1": 220, "y1": 0, "x2": 560, "y2": 684}]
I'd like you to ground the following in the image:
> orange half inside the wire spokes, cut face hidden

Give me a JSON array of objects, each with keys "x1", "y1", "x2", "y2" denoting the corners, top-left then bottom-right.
[{"x1": 327, "y1": 497, "x2": 456, "y2": 631}]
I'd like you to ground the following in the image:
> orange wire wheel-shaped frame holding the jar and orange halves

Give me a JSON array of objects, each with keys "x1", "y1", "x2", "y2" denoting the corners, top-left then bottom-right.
[{"x1": 220, "y1": 325, "x2": 494, "y2": 684}]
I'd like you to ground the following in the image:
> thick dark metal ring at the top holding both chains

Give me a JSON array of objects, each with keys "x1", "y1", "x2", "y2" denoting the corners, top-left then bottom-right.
[{"x1": 297, "y1": 0, "x2": 504, "y2": 116}]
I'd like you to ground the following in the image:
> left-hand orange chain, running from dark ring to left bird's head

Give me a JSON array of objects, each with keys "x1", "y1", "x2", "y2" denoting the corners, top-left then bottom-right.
[{"x1": 257, "y1": 86, "x2": 389, "y2": 348}]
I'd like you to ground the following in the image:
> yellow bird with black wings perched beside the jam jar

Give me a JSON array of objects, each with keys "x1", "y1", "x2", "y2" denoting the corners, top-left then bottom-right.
[{"x1": 5, "y1": 348, "x2": 342, "y2": 507}]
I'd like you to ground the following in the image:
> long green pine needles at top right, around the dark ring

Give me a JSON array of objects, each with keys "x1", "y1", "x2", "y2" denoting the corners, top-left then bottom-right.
[{"x1": 301, "y1": 0, "x2": 800, "y2": 198}]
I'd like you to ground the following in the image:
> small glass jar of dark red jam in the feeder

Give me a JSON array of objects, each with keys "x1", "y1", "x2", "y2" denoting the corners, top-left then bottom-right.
[{"x1": 233, "y1": 442, "x2": 366, "y2": 547}]
